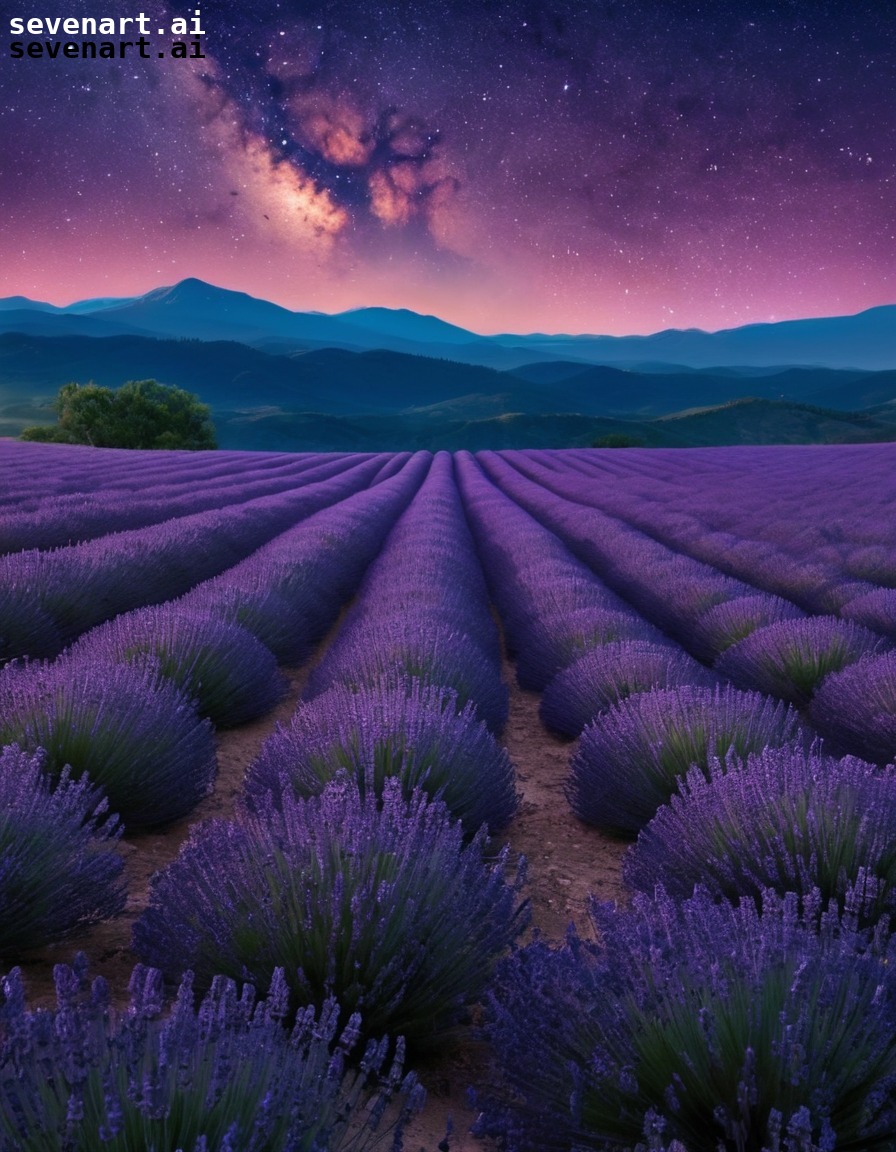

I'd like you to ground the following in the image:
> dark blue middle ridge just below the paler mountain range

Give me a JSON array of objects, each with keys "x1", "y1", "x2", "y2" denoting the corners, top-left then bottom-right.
[{"x1": 0, "y1": 333, "x2": 896, "y2": 418}]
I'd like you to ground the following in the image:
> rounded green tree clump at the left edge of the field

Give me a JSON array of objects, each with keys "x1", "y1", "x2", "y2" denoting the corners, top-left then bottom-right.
[{"x1": 22, "y1": 380, "x2": 218, "y2": 449}]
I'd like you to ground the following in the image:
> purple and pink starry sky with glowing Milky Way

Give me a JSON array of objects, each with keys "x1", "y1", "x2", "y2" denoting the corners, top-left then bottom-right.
[{"x1": 0, "y1": 0, "x2": 896, "y2": 334}]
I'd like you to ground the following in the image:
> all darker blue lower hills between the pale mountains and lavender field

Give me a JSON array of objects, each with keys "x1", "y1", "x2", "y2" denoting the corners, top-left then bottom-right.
[{"x1": 0, "y1": 329, "x2": 896, "y2": 447}]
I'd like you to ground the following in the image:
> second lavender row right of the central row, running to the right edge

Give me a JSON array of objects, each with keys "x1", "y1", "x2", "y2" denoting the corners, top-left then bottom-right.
[{"x1": 479, "y1": 453, "x2": 896, "y2": 764}]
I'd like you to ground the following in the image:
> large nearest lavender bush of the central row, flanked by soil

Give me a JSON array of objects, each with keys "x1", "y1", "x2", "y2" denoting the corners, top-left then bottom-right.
[{"x1": 134, "y1": 775, "x2": 527, "y2": 1047}]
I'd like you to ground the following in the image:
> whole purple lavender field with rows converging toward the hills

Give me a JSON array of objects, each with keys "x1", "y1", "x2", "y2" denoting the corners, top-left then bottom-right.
[{"x1": 0, "y1": 441, "x2": 896, "y2": 1152}]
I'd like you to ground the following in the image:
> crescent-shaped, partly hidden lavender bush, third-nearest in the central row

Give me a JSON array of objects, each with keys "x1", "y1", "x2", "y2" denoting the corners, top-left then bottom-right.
[{"x1": 305, "y1": 617, "x2": 508, "y2": 733}]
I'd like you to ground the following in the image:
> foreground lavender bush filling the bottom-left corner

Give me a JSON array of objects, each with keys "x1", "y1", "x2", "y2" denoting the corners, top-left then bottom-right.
[{"x1": 0, "y1": 954, "x2": 425, "y2": 1152}]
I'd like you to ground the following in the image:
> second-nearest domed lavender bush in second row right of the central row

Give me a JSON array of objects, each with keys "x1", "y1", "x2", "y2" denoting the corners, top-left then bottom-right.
[{"x1": 715, "y1": 616, "x2": 888, "y2": 706}]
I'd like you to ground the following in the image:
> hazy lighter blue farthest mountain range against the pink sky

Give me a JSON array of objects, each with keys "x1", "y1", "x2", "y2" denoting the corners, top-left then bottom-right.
[{"x1": 0, "y1": 279, "x2": 896, "y2": 374}]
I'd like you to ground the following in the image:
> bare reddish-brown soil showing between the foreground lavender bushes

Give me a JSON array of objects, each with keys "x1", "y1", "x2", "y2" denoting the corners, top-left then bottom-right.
[{"x1": 6, "y1": 657, "x2": 627, "y2": 1152}]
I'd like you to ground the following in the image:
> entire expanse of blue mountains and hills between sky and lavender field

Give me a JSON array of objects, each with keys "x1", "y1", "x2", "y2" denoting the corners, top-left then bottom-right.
[{"x1": 0, "y1": 279, "x2": 896, "y2": 450}]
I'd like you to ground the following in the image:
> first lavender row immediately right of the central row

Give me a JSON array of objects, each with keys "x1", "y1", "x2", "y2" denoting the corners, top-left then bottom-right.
[{"x1": 458, "y1": 456, "x2": 803, "y2": 833}]
